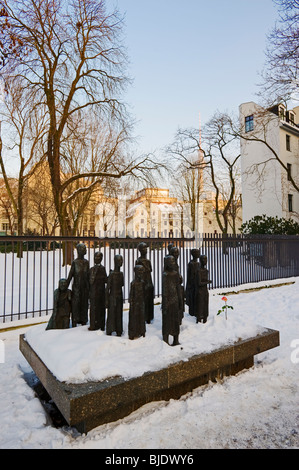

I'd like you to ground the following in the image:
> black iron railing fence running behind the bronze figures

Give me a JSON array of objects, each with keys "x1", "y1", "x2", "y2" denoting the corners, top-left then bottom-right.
[{"x1": 0, "y1": 234, "x2": 299, "y2": 323}]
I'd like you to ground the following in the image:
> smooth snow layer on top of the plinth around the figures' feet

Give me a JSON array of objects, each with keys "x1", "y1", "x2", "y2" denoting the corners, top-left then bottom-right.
[{"x1": 25, "y1": 299, "x2": 266, "y2": 384}]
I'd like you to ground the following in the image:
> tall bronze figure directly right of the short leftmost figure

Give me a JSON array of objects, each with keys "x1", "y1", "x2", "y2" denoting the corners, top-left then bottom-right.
[{"x1": 67, "y1": 243, "x2": 89, "y2": 327}]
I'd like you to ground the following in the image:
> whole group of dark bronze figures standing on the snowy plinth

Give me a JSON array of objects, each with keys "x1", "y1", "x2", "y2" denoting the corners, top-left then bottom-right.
[{"x1": 47, "y1": 242, "x2": 212, "y2": 346}]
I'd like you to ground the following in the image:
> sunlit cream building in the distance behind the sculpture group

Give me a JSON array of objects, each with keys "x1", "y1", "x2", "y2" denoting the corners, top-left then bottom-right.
[{"x1": 96, "y1": 188, "x2": 241, "y2": 237}]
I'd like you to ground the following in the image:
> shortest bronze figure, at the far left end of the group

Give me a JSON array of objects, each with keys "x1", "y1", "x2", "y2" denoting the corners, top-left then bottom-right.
[{"x1": 46, "y1": 279, "x2": 72, "y2": 330}]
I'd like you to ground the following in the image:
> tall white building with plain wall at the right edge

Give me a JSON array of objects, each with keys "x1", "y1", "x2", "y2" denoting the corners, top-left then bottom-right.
[{"x1": 239, "y1": 102, "x2": 299, "y2": 222}]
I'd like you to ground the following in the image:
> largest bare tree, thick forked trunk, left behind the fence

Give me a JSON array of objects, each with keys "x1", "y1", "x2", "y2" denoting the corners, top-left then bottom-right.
[{"x1": 0, "y1": 0, "x2": 159, "y2": 250}]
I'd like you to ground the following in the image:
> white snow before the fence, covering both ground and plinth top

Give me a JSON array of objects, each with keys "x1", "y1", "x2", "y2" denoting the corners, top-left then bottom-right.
[{"x1": 0, "y1": 278, "x2": 299, "y2": 449}]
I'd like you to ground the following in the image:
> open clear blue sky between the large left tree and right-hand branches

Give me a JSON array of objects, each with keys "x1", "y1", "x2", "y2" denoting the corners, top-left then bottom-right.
[{"x1": 111, "y1": 0, "x2": 277, "y2": 158}]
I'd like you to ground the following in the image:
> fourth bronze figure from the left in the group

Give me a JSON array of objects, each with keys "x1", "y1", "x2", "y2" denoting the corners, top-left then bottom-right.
[{"x1": 106, "y1": 255, "x2": 124, "y2": 336}]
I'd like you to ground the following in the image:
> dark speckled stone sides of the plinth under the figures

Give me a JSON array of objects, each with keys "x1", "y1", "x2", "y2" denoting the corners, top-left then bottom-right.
[{"x1": 20, "y1": 329, "x2": 279, "y2": 433}]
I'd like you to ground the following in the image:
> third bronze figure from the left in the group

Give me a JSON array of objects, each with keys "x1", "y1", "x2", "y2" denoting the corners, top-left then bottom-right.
[{"x1": 89, "y1": 251, "x2": 108, "y2": 331}]
